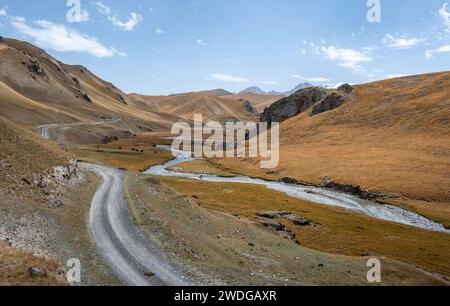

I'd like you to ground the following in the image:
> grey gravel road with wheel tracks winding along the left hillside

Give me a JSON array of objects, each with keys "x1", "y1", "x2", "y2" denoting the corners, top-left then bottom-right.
[{"x1": 39, "y1": 121, "x2": 189, "y2": 286}]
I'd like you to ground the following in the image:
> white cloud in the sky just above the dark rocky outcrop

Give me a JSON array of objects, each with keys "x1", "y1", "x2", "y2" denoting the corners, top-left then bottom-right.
[{"x1": 320, "y1": 46, "x2": 373, "y2": 71}]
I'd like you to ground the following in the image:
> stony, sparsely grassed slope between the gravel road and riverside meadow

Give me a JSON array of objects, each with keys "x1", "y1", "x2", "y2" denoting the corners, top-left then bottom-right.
[{"x1": 126, "y1": 175, "x2": 443, "y2": 285}]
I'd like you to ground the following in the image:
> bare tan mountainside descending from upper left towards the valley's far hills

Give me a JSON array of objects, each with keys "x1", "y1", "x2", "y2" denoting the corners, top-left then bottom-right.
[{"x1": 0, "y1": 37, "x2": 257, "y2": 133}]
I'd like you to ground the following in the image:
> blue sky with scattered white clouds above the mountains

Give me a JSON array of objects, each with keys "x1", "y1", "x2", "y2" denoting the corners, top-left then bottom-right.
[{"x1": 0, "y1": 0, "x2": 450, "y2": 94}]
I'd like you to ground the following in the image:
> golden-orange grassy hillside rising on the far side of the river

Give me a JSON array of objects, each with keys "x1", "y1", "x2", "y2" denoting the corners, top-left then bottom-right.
[{"x1": 214, "y1": 73, "x2": 450, "y2": 206}]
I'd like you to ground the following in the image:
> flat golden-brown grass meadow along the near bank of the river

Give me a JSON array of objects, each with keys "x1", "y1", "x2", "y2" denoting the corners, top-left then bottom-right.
[{"x1": 162, "y1": 178, "x2": 450, "y2": 275}]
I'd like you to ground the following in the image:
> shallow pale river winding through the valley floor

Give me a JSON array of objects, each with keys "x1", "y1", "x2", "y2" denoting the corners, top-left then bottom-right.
[{"x1": 145, "y1": 145, "x2": 450, "y2": 234}]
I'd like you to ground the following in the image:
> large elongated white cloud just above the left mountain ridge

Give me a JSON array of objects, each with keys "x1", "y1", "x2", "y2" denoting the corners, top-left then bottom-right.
[{"x1": 11, "y1": 18, "x2": 117, "y2": 57}]
